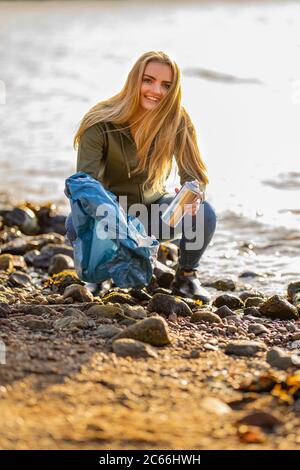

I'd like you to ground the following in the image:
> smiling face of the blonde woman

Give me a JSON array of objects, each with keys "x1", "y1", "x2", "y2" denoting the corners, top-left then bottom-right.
[{"x1": 140, "y1": 62, "x2": 173, "y2": 111}]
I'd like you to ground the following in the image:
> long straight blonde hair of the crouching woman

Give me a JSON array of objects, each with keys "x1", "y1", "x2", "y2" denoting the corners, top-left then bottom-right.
[{"x1": 74, "y1": 51, "x2": 208, "y2": 190}]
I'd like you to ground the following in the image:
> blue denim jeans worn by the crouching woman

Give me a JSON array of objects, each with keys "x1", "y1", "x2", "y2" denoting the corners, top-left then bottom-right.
[{"x1": 66, "y1": 194, "x2": 217, "y2": 271}]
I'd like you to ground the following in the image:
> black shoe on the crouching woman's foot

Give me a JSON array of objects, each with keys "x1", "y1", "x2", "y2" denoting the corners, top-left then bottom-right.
[{"x1": 171, "y1": 270, "x2": 211, "y2": 304}]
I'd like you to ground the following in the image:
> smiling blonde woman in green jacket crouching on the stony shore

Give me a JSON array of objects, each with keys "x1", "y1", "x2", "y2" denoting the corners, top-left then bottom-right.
[{"x1": 67, "y1": 51, "x2": 216, "y2": 303}]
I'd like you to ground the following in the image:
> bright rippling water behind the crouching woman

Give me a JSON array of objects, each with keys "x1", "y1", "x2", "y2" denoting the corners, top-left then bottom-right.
[{"x1": 0, "y1": 1, "x2": 300, "y2": 292}]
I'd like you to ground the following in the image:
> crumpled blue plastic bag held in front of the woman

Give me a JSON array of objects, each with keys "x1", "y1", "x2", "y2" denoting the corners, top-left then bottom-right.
[{"x1": 65, "y1": 172, "x2": 159, "y2": 287}]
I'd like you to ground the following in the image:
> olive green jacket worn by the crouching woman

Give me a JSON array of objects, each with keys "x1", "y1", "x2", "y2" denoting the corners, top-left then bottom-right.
[{"x1": 77, "y1": 122, "x2": 195, "y2": 206}]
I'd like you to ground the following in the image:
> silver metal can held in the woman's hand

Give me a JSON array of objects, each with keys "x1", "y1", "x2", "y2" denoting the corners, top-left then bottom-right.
[{"x1": 161, "y1": 180, "x2": 204, "y2": 227}]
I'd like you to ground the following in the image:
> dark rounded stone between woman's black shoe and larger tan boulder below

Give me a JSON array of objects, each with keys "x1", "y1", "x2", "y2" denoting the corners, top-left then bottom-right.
[{"x1": 148, "y1": 294, "x2": 192, "y2": 317}]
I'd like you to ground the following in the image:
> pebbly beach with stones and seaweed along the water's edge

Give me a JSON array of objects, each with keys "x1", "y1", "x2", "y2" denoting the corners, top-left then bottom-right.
[{"x1": 0, "y1": 203, "x2": 300, "y2": 449}]
